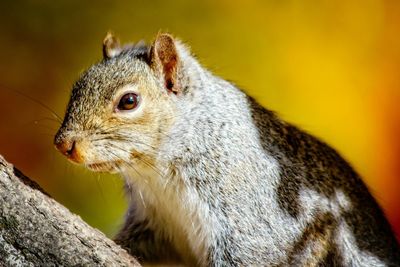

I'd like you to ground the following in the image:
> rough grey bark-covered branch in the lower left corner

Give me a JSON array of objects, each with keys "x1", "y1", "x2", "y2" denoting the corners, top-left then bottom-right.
[{"x1": 0, "y1": 156, "x2": 140, "y2": 266}]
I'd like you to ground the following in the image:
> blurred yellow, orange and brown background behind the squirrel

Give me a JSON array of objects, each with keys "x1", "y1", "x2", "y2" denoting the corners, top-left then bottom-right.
[{"x1": 0, "y1": 0, "x2": 400, "y2": 239}]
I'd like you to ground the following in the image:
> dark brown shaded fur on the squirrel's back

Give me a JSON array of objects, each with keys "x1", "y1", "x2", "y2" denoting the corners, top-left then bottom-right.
[{"x1": 250, "y1": 100, "x2": 400, "y2": 266}]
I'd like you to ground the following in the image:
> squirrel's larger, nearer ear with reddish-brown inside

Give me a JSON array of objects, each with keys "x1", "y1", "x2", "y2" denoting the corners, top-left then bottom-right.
[{"x1": 149, "y1": 33, "x2": 180, "y2": 94}]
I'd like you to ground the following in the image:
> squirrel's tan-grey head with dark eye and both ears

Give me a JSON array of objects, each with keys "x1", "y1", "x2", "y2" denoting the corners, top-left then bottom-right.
[{"x1": 54, "y1": 34, "x2": 187, "y2": 172}]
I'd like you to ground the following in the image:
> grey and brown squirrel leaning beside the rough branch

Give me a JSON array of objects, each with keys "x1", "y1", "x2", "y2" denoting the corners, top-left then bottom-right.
[{"x1": 54, "y1": 33, "x2": 400, "y2": 266}]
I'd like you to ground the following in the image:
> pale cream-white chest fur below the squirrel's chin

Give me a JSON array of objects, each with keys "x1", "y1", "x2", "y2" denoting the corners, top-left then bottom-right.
[{"x1": 124, "y1": 162, "x2": 218, "y2": 265}]
